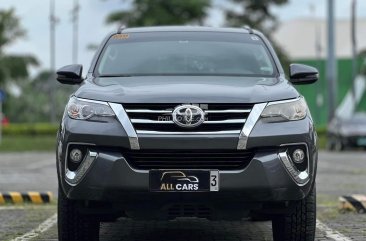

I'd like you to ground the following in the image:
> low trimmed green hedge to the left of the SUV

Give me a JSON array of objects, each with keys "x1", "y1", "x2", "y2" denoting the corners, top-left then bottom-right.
[{"x1": 3, "y1": 123, "x2": 58, "y2": 136}]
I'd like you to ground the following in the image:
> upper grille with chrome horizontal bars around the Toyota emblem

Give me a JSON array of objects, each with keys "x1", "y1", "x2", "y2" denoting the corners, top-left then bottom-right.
[{"x1": 123, "y1": 104, "x2": 253, "y2": 134}]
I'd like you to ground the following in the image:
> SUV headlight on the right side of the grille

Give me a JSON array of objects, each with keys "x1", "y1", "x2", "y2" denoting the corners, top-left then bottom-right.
[{"x1": 261, "y1": 97, "x2": 308, "y2": 122}]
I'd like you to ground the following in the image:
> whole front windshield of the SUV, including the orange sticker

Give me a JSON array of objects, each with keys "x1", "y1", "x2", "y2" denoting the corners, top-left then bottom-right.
[{"x1": 97, "y1": 32, "x2": 275, "y2": 77}]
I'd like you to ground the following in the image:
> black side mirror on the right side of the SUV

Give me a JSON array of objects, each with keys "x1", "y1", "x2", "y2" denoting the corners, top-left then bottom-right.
[{"x1": 290, "y1": 64, "x2": 319, "y2": 85}]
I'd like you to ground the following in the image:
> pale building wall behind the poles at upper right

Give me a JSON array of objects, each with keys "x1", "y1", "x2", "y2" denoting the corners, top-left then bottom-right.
[{"x1": 272, "y1": 17, "x2": 366, "y2": 59}]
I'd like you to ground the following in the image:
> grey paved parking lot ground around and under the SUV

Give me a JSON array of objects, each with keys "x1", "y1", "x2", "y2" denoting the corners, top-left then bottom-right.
[{"x1": 0, "y1": 151, "x2": 366, "y2": 241}]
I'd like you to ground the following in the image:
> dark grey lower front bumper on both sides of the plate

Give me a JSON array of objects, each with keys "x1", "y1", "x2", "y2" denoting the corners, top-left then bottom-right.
[{"x1": 58, "y1": 149, "x2": 316, "y2": 202}]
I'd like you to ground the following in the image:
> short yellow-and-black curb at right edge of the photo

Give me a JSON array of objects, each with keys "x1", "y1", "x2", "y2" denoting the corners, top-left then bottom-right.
[{"x1": 339, "y1": 194, "x2": 366, "y2": 213}]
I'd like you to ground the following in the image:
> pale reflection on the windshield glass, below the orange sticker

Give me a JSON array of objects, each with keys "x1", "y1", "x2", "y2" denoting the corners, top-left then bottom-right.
[{"x1": 98, "y1": 40, "x2": 274, "y2": 77}]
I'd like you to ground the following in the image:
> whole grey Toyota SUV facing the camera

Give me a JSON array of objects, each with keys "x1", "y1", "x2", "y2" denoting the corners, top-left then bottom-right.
[{"x1": 57, "y1": 27, "x2": 318, "y2": 241}]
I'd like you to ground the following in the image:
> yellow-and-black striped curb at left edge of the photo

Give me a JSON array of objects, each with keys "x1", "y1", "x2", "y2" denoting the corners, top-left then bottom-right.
[{"x1": 0, "y1": 192, "x2": 53, "y2": 205}]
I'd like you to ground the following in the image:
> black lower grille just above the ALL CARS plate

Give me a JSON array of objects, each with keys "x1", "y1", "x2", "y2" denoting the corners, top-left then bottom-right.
[{"x1": 123, "y1": 150, "x2": 254, "y2": 170}]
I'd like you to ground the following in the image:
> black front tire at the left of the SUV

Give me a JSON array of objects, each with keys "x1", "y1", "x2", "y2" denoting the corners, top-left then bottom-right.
[{"x1": 57, "y1": 187, "x2": 100, "y2": 241}]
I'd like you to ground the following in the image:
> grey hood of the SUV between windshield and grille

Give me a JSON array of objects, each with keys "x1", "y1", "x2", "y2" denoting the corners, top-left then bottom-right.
[{"x1": 75, "y1": 76, "x2": 299, "y2": 103}]
